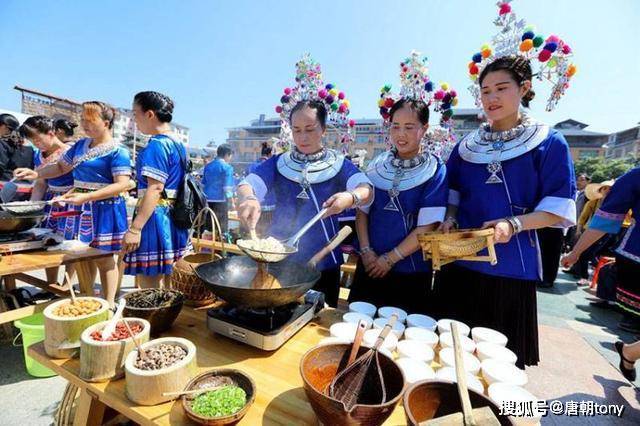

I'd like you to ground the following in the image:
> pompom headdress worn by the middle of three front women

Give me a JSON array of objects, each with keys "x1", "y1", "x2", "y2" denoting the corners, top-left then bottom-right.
[{"x1": 378, "y1": 50, "x2": 458, "y2": 158}]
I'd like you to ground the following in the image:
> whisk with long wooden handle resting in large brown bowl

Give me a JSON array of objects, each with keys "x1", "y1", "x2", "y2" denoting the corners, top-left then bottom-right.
[{"x1": 329, "y1": 314, "x2": 398, "y2": 412}]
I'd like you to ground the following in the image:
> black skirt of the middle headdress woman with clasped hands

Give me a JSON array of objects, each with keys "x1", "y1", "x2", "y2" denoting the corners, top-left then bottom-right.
[{"x1": 349, "y1": 262, "x2": 437, "y2": 316}]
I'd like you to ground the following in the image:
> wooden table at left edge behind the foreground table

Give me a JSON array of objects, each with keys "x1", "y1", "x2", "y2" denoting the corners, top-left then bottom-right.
[{"x1": 0, "y1": 247, "x2": 113, "y2": 324}]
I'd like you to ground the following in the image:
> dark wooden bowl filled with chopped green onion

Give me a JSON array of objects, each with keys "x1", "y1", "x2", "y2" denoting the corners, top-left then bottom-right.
[{"x1": 182, "y1": 368, "x2": 256, "y2": 426}]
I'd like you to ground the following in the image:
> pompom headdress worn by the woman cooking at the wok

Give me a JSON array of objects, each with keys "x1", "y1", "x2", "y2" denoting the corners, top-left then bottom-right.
[{"x1": 276, "y1": 53, "x2": 356, "y2": 153}]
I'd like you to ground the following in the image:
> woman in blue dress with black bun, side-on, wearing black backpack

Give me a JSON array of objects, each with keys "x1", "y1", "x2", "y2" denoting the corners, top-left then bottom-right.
[{"x1": 123, "y1": 92, "x2": 190, "y2": 288}]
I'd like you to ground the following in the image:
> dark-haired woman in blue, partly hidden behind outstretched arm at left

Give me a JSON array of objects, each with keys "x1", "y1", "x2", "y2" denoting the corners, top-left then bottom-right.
[{"x1": 19, "y1": 115, "x2": 76, "y2": 285}]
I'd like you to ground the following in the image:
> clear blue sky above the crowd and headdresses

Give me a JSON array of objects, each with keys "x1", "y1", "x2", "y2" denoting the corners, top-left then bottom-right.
[{"x1": 0, "y1": 0, "x2": 640, "y2": 145}]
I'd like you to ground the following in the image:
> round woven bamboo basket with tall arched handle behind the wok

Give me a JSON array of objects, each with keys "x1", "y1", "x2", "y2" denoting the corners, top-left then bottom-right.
[{"x1": 171, "y1": 207, "x2": 225, "y2": 307}]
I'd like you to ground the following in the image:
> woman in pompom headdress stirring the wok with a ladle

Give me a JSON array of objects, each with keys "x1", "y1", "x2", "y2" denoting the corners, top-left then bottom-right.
[{"x1": 238, "y1": 57, "x2": 373, "y2": 306}]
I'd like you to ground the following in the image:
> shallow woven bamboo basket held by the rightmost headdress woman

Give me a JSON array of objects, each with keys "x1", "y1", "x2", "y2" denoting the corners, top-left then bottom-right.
[{"x1": 418, "y1": 228, "x2": 498, "y2": 271}]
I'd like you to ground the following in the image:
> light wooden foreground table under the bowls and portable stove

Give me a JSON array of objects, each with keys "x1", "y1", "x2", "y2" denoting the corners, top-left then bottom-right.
[{"x1": 29, "y1": 307, "x2": 405, "y2": 425}]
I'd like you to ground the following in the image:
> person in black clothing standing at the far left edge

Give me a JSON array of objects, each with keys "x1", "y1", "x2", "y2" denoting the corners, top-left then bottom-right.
[{"x1": 0, "y1": 114, "x2": 34, "y2": 194}]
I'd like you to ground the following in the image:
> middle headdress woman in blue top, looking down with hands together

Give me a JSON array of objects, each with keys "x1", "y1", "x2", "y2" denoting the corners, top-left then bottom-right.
[{"x1": 349, "y1": 52, "x2": 455, "y2": 315}]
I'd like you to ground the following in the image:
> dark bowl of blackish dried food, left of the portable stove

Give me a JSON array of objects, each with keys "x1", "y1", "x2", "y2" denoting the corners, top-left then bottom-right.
[{"x1": 124, "y1": 288, "x2": 184, "y2": 336}]
